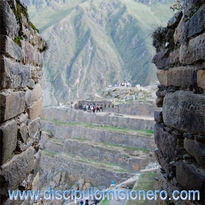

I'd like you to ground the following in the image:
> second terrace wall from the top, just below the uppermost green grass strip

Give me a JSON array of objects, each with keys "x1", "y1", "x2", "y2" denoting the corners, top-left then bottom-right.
[{"x1": 41, "y1": 120, "x2": 156, "y2": 151}]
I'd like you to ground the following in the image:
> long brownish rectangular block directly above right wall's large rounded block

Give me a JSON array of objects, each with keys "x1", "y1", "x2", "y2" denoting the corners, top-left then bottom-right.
[{"x1": 157, "y1": 66, "x2": 196, "y2": 88}]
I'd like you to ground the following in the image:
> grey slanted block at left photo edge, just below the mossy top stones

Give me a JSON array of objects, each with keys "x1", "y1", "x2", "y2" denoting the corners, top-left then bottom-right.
[{"x1": 0, "y1": 35, "x2": 23, "y2": 61}]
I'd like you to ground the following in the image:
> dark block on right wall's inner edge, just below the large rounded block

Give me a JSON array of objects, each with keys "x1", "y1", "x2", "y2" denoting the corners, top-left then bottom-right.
[{"x1": 154, "y1": 124, "x2": 177, "y2": 159}]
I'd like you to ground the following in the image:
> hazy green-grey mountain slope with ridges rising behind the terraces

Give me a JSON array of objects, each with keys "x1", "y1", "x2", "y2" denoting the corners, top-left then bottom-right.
[{"x1": 25, "y1": 0, "x2": 172, "y2": 105}]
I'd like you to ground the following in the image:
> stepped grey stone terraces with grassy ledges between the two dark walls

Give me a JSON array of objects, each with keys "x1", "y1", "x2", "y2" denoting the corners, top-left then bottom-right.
[{"x1": 40, "y1": 104, "x2": 155, "y2": 187}]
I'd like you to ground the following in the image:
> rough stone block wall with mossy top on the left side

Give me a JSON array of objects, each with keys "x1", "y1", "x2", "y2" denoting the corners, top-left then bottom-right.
[{"x1": 0, "y1": 0, "x2": 46, "y2": 204}]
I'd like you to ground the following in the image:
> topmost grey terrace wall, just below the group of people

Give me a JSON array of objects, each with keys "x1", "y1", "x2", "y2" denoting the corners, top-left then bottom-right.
[{"x1": 42, "y1": 107, "x2": 154, "y2": 130}]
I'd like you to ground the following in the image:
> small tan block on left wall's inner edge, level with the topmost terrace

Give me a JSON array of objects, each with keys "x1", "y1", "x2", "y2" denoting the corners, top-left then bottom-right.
[{"x1": 28, "y1": 98, "x2": 42, "y2": 120}]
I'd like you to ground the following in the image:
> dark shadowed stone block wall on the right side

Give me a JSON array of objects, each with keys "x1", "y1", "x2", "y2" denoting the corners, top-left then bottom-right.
[{"x1": 153, "y1": 0, "x2": 205, "y2": 204}]
